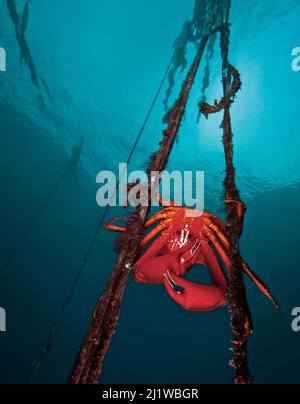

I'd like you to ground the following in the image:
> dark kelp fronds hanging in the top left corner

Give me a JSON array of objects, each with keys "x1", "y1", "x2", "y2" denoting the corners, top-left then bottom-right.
[{"x1": 6, "y1": 0, "x2": 54, "y2": 107}]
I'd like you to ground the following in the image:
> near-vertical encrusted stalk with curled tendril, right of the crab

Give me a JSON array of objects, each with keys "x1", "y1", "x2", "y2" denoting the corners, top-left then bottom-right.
[{"x1": 199, "y1": 0, "x2": 253, "y2": 384}]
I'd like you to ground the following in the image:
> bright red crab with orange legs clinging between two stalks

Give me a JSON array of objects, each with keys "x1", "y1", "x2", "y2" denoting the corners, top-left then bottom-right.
[{"x1": 105, "y1": 197, "x2": 278, "y2": 340}]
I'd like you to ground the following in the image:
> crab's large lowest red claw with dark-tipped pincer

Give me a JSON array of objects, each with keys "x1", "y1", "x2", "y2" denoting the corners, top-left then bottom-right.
[{"x1": 164, "y1": 271, "x2": 227, "y2": 311}]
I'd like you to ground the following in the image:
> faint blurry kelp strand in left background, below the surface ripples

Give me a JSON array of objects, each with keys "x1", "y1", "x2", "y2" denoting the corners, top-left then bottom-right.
[{"x1": 0, "y1": 137, "x2": 84, "y2": 277}]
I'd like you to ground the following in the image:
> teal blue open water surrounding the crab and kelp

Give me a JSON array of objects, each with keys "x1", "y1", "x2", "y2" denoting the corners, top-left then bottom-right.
[{"x1": 0, "y1": 0, "x2": 300, "y2": 383}]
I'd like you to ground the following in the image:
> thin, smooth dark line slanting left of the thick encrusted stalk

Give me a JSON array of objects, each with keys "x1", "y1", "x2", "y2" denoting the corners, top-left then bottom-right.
[{"x1": 28, "y1": 57, "x2": 171, "y2": 384}]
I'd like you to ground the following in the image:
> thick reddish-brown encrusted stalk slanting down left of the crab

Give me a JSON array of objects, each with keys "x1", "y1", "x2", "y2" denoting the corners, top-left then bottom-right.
[{"x1": 69, "y1": 35, "x2": 209, "y2": 384}]
